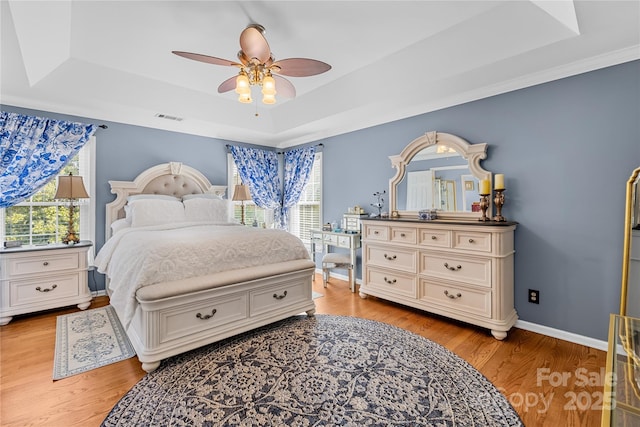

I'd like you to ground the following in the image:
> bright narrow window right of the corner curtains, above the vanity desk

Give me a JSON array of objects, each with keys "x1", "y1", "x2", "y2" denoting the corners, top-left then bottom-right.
[{"x1": 289, "y1": 153, "x2": 322, "y2": 250}]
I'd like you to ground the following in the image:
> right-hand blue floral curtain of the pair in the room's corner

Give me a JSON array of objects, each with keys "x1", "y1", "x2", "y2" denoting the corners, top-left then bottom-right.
[{"x1": 281, "y1": 147, "x2": 316, "y2": 228}]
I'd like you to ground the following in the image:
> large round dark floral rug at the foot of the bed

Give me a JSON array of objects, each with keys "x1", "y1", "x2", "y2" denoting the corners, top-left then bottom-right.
[{"x1": 102, "y1": 315, "x2": 523, "y2": 427}]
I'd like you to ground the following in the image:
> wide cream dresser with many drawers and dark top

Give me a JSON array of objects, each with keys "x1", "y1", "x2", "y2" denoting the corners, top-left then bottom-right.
[{"x1": 360, "y1": 219, "x2": 518, "y2": 340}]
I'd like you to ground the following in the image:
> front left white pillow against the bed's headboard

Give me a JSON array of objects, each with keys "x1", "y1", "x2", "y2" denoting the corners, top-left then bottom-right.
[{"x1": 128, "y1": 198, "x2": 185, "y2": 227}]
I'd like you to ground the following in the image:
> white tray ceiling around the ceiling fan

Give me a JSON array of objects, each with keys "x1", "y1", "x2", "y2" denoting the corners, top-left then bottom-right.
[{"x1": 0, "y1": 0, "x2": 640, "y2": 147}]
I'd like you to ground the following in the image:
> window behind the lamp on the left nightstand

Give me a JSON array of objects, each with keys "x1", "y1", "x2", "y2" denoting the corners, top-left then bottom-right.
[{"x1": 0, "y1": 137, "x2": 95, "y2": 249}]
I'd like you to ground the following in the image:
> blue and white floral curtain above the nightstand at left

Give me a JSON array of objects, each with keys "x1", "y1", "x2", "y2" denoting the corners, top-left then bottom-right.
[{"x1": 0, "y1": 111, "x2": 96, "y2": 208}]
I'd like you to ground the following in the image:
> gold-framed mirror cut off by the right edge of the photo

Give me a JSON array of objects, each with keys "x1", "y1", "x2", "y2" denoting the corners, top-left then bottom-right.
[{"x1": 620, "y1": 168, "x2": 640, "y2": 317}]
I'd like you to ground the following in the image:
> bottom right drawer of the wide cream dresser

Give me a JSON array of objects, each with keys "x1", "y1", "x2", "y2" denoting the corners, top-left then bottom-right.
[{"x1": 420, "y1": 279, "x2": 491, "y2": 318}]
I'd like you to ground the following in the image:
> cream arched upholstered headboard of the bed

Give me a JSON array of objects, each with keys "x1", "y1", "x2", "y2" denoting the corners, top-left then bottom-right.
[{"x1": 104, "y1": 162, "x2": 227, "y2": 241}]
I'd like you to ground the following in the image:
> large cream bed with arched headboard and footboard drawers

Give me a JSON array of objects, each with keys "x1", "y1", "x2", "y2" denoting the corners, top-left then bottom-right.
[{"x1": 95, "y1": 162, "x2": 315, "y2": 372}]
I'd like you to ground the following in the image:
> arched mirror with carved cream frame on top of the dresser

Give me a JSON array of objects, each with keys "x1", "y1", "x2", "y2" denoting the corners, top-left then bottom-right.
[{"x1": 389, "y1": 132, "x2": 491, "y2": 219}]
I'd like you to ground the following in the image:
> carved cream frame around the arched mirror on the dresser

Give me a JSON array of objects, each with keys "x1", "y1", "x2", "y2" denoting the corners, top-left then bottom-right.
[{"x1": 389, "y1": 131, "x2": 493, "y2": 220}]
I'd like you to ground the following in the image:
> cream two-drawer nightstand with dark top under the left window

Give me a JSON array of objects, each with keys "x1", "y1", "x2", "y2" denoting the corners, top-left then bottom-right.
[{"x1": 0, "y1": 241, "x2": 93, "y2": 325}]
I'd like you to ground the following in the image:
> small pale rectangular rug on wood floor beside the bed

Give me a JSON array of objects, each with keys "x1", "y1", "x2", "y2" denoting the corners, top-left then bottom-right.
[{"x1": 53, "y1": 305, "x2": 136, "y2": 380}]
